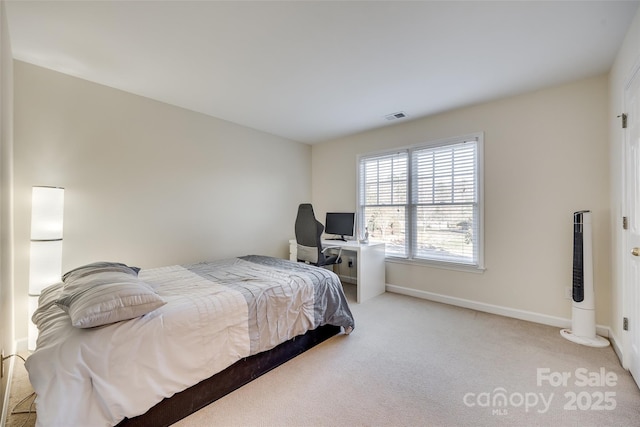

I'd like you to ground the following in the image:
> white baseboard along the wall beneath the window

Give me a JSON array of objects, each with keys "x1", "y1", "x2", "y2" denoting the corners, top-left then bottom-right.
[{"x1": 386, "y1": 284, "x2": 610, "y2": 337}]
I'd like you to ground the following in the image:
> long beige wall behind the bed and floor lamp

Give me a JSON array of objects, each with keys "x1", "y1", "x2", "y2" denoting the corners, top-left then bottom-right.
[{"x1": 14, "y1": 61, "x2": 311, "y2": 337}]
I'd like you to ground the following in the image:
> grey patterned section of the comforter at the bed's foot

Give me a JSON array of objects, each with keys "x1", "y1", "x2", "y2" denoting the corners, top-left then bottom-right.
[{"x1": 188, "y1": 255, "x2": 355, "y2": 354}]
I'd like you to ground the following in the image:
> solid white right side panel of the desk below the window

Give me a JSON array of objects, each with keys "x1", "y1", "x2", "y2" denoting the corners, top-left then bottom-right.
[{"x1": 357, "y1": 245, "x2": 386, "y2": 303}]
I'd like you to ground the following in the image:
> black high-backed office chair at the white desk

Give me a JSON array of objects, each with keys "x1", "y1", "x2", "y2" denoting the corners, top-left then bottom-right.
[{"x1": 296, "y1": 203, "x2": 342, "y2": 267}]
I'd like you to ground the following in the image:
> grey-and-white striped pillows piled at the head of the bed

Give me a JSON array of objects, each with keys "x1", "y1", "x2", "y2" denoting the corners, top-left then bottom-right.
[{"x1": 56, "y1": 263, "x2": 166, "y2": 328}]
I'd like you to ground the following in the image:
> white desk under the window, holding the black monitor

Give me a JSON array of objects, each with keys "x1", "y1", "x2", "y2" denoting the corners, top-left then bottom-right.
[{"x1": 289, "y1": 239, "x2": 386, "y2": 303}]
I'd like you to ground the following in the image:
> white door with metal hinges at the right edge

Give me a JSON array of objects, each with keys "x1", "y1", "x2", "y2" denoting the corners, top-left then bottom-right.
[{"x1": 623, "y1": 64, "x2": 640, "y2": 387}]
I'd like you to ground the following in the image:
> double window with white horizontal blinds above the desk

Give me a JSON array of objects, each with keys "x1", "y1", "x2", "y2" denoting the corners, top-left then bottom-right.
[{"x1": 358, "y1": 134, "x2": 483, "y2": 268}]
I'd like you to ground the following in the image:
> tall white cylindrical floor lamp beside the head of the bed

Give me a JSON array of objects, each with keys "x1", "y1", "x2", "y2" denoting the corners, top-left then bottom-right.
[{"x1": 28, "y1": 186, "x2": 64, "y2": 350}]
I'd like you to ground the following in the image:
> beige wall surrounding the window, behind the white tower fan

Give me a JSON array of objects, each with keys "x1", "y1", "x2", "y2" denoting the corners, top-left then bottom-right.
[{"x1": 312, "y1": 76, "x2": 611, "y2": 325}]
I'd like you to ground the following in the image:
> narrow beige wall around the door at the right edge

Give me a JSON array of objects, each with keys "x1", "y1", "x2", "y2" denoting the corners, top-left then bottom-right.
[{"x1": 607, "y1": 9, "x2": 640, "y2": 358}]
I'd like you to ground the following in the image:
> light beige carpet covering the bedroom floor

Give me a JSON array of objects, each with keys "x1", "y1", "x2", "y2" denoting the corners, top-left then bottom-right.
[{"x1": 9, "y1": 285, "x2": 640, "y2": 427}]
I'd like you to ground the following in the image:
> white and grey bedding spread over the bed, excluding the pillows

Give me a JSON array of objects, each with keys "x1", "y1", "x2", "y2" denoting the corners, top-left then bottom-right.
[{"x1": 26, "y1": 258, "x2": 353, "y2": 427}]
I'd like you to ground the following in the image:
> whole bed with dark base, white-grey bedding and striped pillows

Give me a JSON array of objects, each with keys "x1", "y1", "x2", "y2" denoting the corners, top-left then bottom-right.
[{"x1": 26, "y1": 255, "x2": 354, "y2": 426}]
